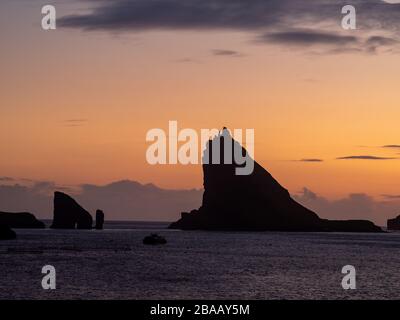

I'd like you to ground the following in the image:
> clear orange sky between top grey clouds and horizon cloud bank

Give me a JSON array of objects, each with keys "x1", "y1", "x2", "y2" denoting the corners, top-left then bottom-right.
[{"x1": 0, "y1": 0, "x2": 400, "y2": 197}]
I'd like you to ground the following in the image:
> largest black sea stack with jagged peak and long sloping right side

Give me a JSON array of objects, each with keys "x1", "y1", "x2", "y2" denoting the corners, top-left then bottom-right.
[{"x1": 169, "y1": 128, "x2": 382, "y2": 232}]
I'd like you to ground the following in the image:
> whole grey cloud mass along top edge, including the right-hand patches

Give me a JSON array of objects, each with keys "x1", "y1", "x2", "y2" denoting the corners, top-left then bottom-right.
[{"x1": 57, "y1": 0, "x2": 400, "y2": 53}]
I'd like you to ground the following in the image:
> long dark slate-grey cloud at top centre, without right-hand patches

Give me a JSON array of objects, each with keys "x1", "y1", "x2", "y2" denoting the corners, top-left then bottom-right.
[{"x1": 58, "y1": 0, "x2": 285, "y2": 31}]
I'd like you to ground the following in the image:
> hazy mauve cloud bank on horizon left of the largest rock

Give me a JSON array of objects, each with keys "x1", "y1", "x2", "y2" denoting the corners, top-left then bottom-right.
[{"x1": 0, "y1": 181, "x2": 203, "y2": 221}]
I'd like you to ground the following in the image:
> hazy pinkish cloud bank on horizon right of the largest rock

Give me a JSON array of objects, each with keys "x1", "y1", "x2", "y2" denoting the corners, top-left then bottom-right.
[{"x1": 293, "y1": 188, "x2": 400, "y2": 226}]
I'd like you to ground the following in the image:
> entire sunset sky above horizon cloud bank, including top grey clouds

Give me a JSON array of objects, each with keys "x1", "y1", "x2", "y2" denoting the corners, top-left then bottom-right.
[{"x1": 0, "y1": 0, "x2": 400, "y2": 205}]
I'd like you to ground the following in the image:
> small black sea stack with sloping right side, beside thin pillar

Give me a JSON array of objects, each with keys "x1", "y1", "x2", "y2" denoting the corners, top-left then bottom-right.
[{"x1": 50, "y1": 191, "x2": 93, "y2": 229}]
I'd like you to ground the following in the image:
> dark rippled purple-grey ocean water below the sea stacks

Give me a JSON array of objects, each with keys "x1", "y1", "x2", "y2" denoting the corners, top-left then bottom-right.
[{"x1": 0, "y1": 222, "x2": 400, "y2": 299}]
